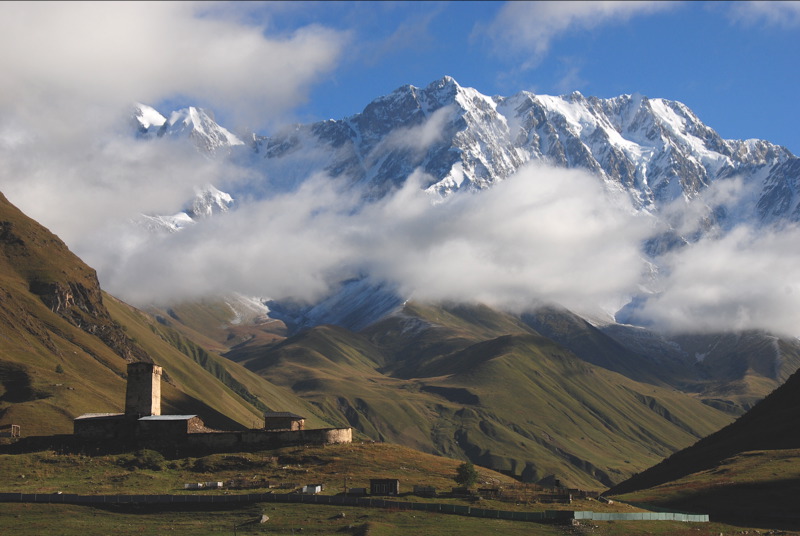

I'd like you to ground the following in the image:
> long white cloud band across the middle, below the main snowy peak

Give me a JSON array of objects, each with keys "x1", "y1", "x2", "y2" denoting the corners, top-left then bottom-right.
[{"x1": 85, "y1": 161, "x2": 647, "y2": 311}]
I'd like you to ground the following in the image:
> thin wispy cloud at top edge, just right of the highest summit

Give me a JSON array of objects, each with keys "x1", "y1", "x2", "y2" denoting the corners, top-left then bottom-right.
[{"x1": 479, "y1": 1, "x2": 674, "y2": 69}]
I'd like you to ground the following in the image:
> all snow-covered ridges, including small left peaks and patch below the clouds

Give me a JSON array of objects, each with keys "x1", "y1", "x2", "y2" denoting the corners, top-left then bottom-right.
[{"x1": 135, "y1": 77, "x2": 800, "y2": 327}]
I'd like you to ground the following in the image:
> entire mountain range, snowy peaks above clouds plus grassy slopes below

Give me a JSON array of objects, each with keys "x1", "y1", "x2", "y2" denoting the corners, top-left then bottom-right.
[{"x1": 0, "y1": 77, "x2": 800, "y2": 489}]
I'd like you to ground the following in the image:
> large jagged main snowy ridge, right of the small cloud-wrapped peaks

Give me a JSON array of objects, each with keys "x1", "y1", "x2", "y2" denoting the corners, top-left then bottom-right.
[{"x1": 241, "y1": 77, "x2": 797, "y2": 224}]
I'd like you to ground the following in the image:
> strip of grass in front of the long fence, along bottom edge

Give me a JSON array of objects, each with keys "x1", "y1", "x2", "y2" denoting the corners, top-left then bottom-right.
[{"x1": 0, "y1": 504, "x2": 768, "y2": 536}]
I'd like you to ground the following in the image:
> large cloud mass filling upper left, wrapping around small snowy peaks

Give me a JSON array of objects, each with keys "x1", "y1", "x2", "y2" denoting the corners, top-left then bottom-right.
[{"x1": 0, "y1": 2, "x2": 348, "y2": 272}]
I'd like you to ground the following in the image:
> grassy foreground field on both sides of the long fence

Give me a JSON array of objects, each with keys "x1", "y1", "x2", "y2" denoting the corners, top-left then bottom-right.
[{"x1": 0, "y1": 443, "x2": 800, "y2": 536}]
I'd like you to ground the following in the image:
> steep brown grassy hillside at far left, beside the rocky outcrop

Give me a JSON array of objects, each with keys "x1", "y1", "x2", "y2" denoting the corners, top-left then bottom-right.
[{"x1": 0, "y1": 194, "x2": 135, "y2": 435}]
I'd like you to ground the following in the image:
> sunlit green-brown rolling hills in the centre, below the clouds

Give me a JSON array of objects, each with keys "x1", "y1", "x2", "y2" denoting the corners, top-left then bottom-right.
[{"x1": 229, "y1": 304, "x2": 729, "y2": 489}]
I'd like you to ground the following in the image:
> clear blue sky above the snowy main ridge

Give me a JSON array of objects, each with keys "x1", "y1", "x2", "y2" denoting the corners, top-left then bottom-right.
[{"x1": 264, "y1": 2, "x2": 800, "y2": 154}]
